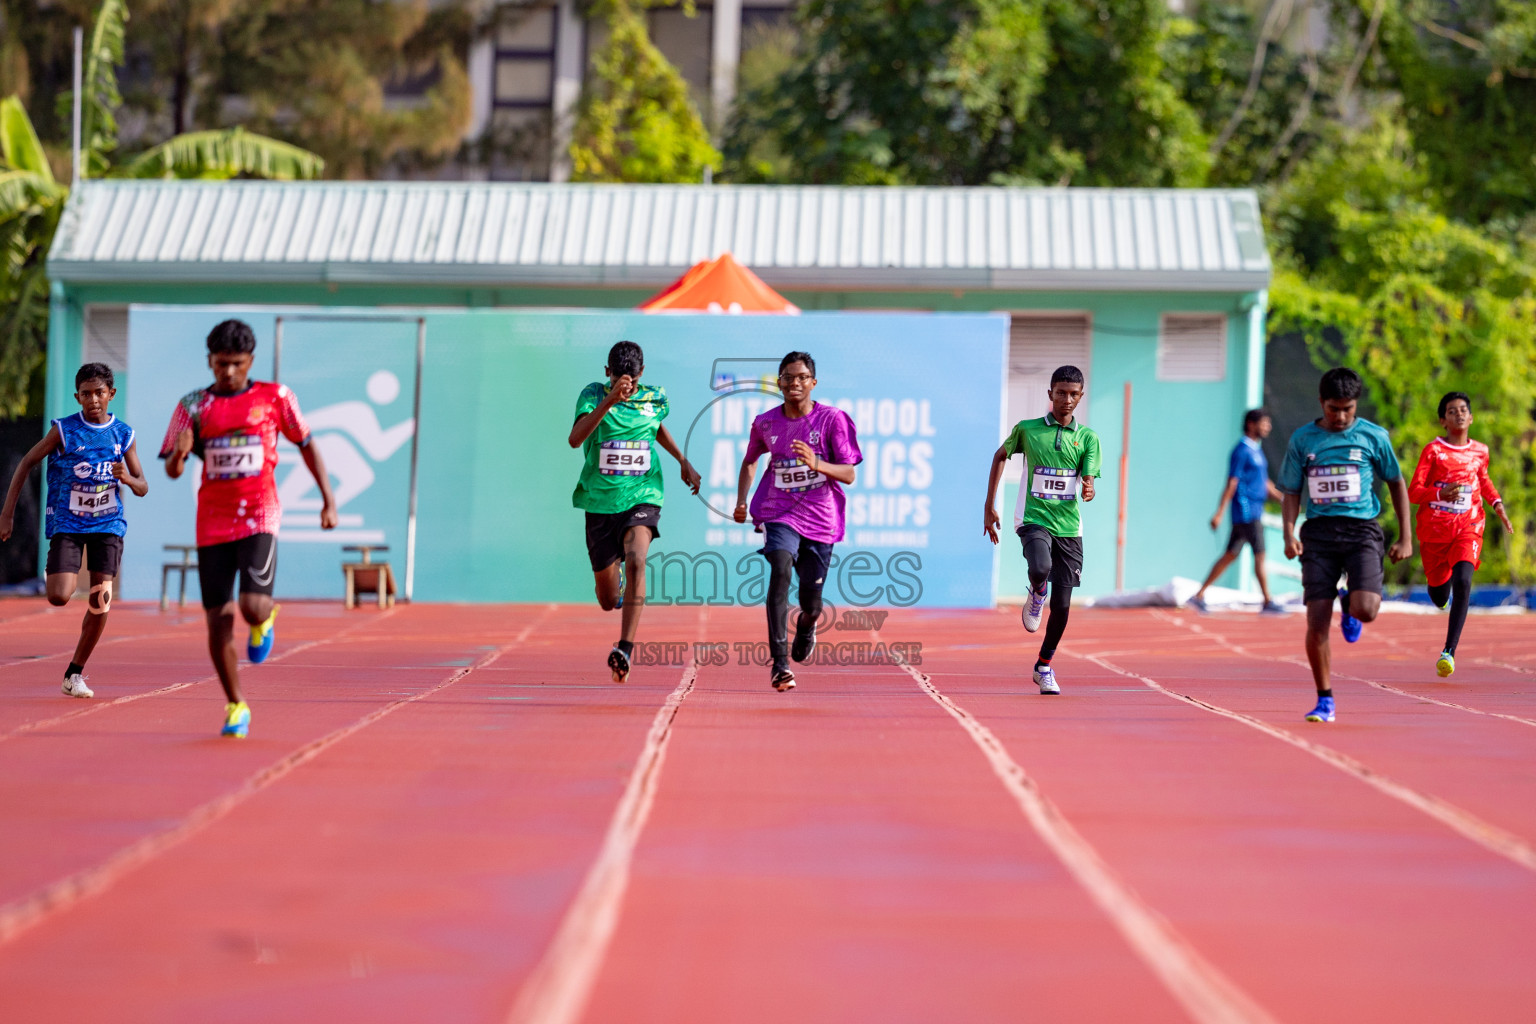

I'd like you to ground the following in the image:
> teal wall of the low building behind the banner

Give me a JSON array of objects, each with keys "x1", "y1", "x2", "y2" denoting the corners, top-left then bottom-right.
[{"x1": 48, "y1": 282, "x2": 1271, "y2": 597}]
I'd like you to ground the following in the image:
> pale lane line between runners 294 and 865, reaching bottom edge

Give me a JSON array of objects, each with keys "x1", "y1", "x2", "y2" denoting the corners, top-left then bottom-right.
[{"x1": 507, "y1": 662, "x2": 699, "y2": 1024}]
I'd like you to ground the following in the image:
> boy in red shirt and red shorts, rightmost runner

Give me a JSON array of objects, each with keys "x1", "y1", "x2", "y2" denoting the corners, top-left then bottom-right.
[{"x1": 1409, "y1": 391, "x2": 1514, "y2": 679}]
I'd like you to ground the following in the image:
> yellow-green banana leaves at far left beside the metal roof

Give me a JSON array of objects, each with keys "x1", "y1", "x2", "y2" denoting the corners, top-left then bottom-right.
[{"x1": 0, "y1": 0, "x2": 326, "y2": 418}]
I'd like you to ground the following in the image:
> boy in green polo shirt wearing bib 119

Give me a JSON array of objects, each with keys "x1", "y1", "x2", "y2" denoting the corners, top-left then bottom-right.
[{"x1": 982, "y1": 367, "x2": 1101, "y2": 694}]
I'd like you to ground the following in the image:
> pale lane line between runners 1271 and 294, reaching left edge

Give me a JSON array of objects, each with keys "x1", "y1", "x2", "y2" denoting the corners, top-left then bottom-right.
[{"x1": 0, "y1": 605, "x2": 556, "y2": 944}]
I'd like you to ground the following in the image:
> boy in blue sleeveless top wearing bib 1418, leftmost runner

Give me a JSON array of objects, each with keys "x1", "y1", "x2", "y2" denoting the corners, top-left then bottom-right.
[{"x1": 0, "y1": 362, "x2": 149, "y2": 697}]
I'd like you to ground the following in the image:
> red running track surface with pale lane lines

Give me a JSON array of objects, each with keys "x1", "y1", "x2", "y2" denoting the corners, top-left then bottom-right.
[{"x1": 0, "y1": 600, "x2": 1536, "y2": 1024}]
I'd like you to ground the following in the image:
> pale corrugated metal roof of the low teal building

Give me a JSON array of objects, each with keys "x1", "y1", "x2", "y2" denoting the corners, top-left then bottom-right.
[{"x1": 48, "y1": 180, "x2": 1270, "y2": 292}]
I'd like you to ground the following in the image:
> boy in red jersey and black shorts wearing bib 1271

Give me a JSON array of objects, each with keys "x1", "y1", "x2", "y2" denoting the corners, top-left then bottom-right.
[{"x1": 160, "y1": 319, "x2": 336, "y2": 737}]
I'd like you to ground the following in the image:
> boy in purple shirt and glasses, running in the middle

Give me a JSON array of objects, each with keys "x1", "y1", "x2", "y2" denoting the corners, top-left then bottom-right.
[{"x1": 736, "y1": 352, "x2": 863, "y2": 692}]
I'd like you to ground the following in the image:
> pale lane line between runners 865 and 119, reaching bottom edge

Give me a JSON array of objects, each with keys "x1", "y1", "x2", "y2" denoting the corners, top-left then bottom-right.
[{"x1": 900, "y1": 662, "x2": 1275, "y2": 1024}]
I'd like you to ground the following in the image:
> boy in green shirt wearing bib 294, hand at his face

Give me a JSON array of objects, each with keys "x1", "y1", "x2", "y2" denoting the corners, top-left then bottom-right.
[{"x1": 568, "y1": 341, "x2": 699, "y2": 683}]
